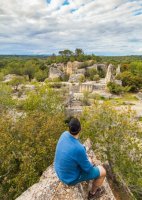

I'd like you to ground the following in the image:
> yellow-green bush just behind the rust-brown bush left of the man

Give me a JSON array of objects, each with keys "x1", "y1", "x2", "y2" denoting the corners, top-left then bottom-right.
[{"x1": 20, "y1": 85, "x2": 64, "y2": 115}]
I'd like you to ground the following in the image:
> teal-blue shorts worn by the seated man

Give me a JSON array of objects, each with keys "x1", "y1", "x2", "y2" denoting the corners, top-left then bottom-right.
[{"x1": 68, "y1": 167, "x2": 100, "y2": 185}]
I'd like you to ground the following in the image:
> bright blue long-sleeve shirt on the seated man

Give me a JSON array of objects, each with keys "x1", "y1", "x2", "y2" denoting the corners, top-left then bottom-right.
[{"x1": 54, "y1": 131, "x2": 93, "y2": 184}]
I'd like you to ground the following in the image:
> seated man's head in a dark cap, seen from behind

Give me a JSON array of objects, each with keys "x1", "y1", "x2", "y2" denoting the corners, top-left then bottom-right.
[{"x1": 68, "y1": 118, "x2": 81, "y2": 135}]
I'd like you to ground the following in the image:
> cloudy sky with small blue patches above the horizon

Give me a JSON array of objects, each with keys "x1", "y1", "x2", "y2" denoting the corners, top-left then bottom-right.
[{"x1": 0, "y1": 0, "x2": 142, "y2": 55}]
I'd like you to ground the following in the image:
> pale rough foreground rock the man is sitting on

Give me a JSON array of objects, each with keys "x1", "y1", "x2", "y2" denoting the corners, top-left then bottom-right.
[{"x1": 16, "y1": 139, "x2": 115, "y2": 200}]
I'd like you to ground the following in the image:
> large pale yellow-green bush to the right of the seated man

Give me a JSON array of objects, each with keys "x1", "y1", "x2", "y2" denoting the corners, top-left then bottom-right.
[{"x1": 81, "y1": 103, "x2": 142, "y2": 200}]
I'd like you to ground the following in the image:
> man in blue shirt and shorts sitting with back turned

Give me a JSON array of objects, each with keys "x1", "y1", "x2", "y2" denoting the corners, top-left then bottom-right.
[{"x1": 54, "y1": 118, "x2": 106, "y2": 199}]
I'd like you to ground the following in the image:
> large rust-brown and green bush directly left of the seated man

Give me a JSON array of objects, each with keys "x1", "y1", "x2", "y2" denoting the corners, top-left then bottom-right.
[{"x1": 0, "y1": 111, "x2": 65, "y2": 200}]
